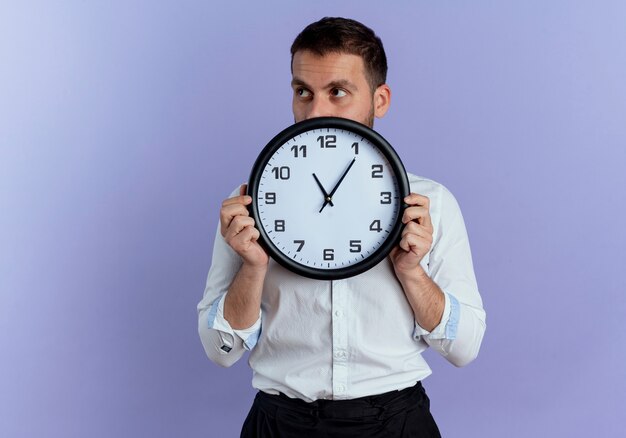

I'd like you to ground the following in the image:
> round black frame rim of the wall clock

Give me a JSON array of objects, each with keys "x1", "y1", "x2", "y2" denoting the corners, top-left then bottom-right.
[{"x1": 247, "y1": 117, "x2": 410, "y2": 280}]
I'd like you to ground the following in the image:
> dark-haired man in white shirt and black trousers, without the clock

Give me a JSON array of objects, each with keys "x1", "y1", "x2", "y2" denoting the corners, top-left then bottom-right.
[{"x1": 198, "y1": 18, "x2": 485, "y2": 437}]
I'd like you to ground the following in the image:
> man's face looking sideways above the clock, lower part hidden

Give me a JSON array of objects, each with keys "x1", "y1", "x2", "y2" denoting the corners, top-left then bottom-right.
[{"x1": 291, "y1": 51, "x2": 388, "y2": 127}]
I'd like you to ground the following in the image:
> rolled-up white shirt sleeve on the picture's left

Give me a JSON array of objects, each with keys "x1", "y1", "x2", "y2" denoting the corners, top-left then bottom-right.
[{"x1": 197, "y1": 189, "x2": 262, "y2": 367}]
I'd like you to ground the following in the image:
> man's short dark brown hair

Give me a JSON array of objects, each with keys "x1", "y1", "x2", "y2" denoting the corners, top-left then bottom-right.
[{"x1": 291, "y1": 17, "x2": 387, "y2": 91}]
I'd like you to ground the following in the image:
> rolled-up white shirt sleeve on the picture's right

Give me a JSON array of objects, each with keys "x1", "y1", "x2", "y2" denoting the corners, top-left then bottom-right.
[{"x1": 414, "y1": 186, "x2": 486, "y2": 366}]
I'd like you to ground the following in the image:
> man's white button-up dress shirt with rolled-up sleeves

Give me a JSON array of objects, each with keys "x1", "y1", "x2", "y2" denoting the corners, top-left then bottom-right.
[{"x1": 198, "y1": 174, "x2": 485, "y2": 402}]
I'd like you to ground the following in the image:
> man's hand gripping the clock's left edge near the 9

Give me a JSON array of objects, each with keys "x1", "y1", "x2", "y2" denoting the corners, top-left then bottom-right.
[{"x1": 220, "y1": 184, "x2": 269, "y2": 269}]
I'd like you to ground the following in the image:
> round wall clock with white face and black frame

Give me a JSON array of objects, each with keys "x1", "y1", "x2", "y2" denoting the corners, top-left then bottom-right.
[{"x1": 248, "y1": 117, "x2": 409, "y2": 280}]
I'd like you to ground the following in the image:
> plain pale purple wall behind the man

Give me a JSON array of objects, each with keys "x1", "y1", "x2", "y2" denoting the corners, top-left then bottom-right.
[{"x1": 0, "y1": 1, "x2": 626, "y2": 438}]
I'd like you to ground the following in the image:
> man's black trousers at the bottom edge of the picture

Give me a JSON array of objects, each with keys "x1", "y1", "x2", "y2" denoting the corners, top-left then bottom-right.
[{"x1": 241, "y1": 382, "x2": 441, "y2": 438}]
